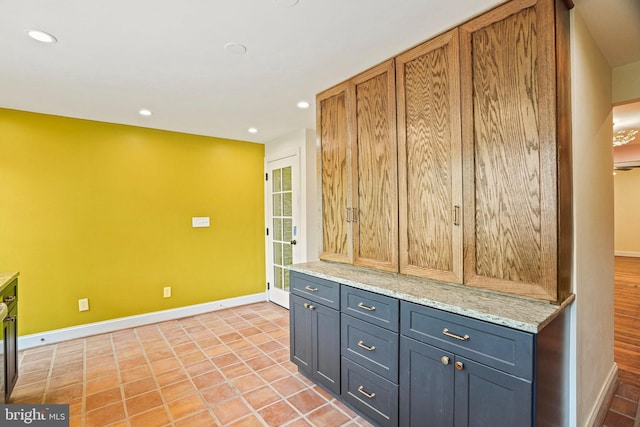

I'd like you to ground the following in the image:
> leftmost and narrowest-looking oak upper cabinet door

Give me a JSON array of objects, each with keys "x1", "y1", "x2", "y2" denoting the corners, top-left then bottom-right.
[{"x1": 316, "y1": 82, "x2": 353, "y2": 263}]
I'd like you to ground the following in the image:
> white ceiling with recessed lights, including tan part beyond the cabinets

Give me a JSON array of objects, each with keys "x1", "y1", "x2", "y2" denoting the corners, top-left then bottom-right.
[{"x1": 0, "y1": 0, "x2": 640, "y2": 142}]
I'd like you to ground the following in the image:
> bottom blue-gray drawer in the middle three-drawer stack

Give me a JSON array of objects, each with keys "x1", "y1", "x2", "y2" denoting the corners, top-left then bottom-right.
[{"x1": 342, "y1": 357, "x2": 398, "y2": 426}]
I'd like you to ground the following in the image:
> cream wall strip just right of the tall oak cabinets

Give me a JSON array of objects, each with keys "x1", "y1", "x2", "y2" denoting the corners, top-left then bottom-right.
[{"x1": 571, "y1": 6, "x2": 617, "y2": 427}]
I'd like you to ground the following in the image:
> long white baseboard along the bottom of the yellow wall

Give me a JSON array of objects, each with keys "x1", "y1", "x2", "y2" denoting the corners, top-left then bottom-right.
[{"x1": 18, "y1": 292, "x2": 267, "y2": 350}]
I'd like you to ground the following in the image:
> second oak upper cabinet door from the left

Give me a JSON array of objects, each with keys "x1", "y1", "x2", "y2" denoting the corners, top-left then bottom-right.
[{"x1": 348, "y1": 60, "x2": 398, "y2": 271}]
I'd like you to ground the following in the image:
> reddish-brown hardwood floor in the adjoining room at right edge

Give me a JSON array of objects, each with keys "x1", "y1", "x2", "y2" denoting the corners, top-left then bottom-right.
[{"x1": 614, "y1": 257, "x2": 640, "y2": 387}]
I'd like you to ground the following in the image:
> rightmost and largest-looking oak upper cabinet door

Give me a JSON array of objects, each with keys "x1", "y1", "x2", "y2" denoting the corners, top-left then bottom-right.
[{"x1": 460, "y1": 0, "x2": 558, "y2": 301}]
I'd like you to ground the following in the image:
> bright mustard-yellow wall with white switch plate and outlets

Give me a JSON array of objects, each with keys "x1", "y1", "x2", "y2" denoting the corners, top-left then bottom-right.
[{"x1": 0, "y1": 109, "x2": 265, "y2": 335}]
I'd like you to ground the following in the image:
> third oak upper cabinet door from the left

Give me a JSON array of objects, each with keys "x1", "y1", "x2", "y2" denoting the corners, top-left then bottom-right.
[{"x1": 396, "y1": 29, "x2": 463, "y2": 283}]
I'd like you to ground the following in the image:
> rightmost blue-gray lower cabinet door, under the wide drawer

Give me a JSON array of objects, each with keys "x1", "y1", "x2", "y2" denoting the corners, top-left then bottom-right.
[{"x1": 454, "y1": 357, "x2": 533, "y2": 427}]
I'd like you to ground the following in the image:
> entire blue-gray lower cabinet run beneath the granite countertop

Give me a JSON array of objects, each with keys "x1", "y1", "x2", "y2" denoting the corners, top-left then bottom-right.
[{"x1": 290, "y1": 272, "x2": 569, "y2": 427}]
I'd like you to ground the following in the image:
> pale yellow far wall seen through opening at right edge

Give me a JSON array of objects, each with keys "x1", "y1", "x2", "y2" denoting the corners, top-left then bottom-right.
[{"x1": 613, "y1": 169, "x2": 640, "y2": 254}]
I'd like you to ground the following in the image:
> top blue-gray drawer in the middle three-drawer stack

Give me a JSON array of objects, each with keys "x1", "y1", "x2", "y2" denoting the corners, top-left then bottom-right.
[{"x1": 341, "y1": 286, "x2": 400, "y2": 332}]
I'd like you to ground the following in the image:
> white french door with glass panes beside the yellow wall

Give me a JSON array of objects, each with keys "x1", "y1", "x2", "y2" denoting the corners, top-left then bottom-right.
[{"x1": 265, "y1": 155, "x2": 300, "y2": 308}]
